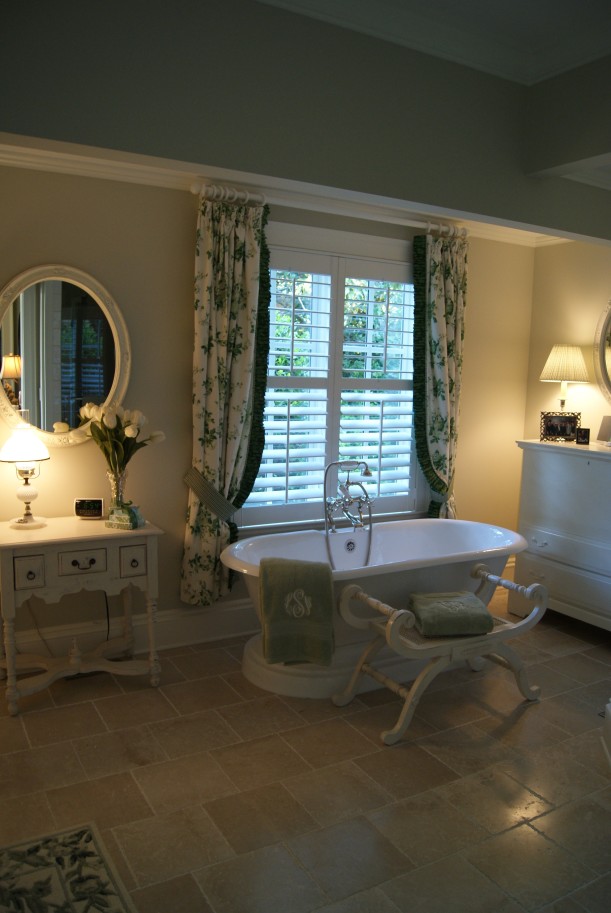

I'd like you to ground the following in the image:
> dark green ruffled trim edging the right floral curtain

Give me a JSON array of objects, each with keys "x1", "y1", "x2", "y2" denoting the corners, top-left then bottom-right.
[{"x1": 412, "y1": 235, "x2": 448, "y2": 517}]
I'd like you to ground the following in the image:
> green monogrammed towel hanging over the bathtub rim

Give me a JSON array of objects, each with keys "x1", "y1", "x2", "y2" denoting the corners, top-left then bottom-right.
[{"x1": 259, "y1": 558, "x2": 334, "y2": 666}]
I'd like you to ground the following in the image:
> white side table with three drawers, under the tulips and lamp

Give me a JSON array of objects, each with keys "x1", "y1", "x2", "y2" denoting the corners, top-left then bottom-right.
[{"x1": 0, "y1": 517, "x2": 162, "y2": 716}]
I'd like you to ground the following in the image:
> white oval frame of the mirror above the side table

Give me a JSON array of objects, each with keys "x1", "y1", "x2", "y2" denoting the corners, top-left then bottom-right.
[{"x1": 0, "y1": 264, "x2": 131, "y2": 447}]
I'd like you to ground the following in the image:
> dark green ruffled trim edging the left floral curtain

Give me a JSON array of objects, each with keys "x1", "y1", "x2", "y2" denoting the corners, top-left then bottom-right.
[{"x1": 229, "y1": 206, "x2": 271, "y2": 542}]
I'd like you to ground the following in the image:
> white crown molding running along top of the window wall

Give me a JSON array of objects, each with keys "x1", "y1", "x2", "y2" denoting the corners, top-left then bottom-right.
[{"x1": 0, "y1": 132, "x2": 570, "y2": 247}]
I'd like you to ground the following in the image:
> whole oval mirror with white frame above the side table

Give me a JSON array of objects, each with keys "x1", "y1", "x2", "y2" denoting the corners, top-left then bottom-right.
[{"x1": 0, "y1": 266, "x2": 129, "y2": 444}]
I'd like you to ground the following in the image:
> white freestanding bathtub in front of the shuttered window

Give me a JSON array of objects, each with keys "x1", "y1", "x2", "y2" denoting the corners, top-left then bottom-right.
[{"x1": 221, "y1": 519, "x2": 527, "y2": 698}]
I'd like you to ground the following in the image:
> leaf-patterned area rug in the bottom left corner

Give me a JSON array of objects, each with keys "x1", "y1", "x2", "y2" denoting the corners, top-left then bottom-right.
[{"x1": 0, "y1": 824, "x2": 136, "y2": 913}]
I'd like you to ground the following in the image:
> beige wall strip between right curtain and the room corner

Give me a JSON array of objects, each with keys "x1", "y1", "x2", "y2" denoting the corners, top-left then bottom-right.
[{"x1": 455, "y1": 238, "x2": 535, "y2": 529}]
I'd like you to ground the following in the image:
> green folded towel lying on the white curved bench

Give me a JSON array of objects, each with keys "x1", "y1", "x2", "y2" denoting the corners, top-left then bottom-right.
[{"x1": 409, "y1": 590, "x2": 494, "y2": 637}]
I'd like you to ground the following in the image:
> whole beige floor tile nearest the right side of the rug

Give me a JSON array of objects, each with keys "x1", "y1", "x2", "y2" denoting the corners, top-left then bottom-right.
[{"x1": 114, "y1": 807, "x2": 234, "y2": 888}]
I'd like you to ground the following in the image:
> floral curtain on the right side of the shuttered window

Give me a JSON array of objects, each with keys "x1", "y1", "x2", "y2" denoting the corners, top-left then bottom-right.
[{"x1": 414, "y1": 234, "x2": 468, "y2": 518}]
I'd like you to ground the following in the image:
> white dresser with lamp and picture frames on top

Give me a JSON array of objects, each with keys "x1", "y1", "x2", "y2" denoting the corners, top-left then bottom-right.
[{"x1": 509, "y1": 441, "x2": 611, "y2": 631}]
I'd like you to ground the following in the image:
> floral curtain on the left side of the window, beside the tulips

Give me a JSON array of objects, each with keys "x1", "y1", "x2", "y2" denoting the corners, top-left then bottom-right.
[{"x1": 181, "y1": 199, "x2": 269, "y2": 605}]
